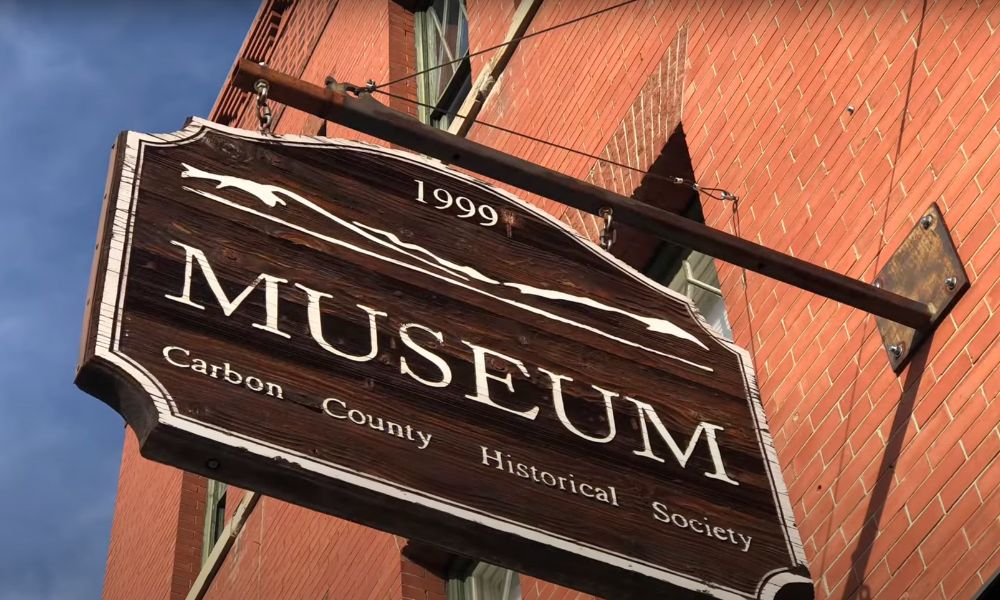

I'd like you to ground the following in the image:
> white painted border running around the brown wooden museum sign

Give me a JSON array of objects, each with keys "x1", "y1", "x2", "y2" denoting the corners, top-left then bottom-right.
[{"x1": 78, "y1": 117, "x2": 811, "y2": 600}]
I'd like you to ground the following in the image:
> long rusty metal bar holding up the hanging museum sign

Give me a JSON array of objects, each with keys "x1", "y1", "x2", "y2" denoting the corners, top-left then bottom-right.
[{"x1": 233, "y1": 59, "x2": 932, "y2": 331}]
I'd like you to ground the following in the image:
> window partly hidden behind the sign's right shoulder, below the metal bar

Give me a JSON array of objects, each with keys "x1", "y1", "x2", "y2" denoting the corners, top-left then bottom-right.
[{"x1": 646, "y1": 200, "x2": 733, "y2": 341}]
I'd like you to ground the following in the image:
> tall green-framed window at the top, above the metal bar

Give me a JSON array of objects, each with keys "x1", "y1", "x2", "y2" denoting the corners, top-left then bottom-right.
[{"x1": 414, "y1": 0, "x2": 472, "y2": 129}]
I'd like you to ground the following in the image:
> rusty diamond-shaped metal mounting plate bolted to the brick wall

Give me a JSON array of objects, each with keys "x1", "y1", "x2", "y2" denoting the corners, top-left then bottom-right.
[{"x1": 875, "y1": 204, "x2": 969, "y2": 373}]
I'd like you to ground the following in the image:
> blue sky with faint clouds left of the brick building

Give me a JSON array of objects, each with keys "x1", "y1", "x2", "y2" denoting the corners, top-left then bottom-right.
[{"x1": 0, "y1": 0, "x2": 258, "y2": 600}]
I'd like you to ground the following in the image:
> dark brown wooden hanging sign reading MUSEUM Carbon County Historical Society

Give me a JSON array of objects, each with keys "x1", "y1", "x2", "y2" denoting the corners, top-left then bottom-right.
[{"x1": 77, "y1": 120, "x2": 812, "y2": 598}]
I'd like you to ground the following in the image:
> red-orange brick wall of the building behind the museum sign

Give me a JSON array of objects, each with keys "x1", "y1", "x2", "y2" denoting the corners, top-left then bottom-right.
[{"x1": 106, "y1": 0, "x2": 1000, "y2": 600}]
